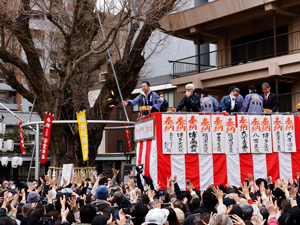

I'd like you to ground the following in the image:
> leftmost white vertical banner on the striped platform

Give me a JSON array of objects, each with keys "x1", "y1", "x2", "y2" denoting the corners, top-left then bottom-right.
[{"x1": 162, "y1": 114, "x2": 176, "y2": 154}]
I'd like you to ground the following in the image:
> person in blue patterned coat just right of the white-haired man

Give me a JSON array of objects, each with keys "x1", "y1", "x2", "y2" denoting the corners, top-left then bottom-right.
[{"x1": 198, "y1": 88, "x2": 220, "y2": 113}]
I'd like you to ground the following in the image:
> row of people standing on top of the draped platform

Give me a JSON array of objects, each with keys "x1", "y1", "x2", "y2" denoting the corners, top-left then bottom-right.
[{"x1": 123, "y1": 81, "x2": 278, "y2": 115}]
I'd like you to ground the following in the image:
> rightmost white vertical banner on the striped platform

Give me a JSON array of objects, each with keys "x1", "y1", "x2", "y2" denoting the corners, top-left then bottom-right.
[{"x1": 283, "y1": 115, "x2": 296, "y2": 152}]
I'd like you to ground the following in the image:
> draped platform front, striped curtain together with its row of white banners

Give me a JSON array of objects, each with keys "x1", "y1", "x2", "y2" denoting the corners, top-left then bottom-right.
[{"x1": 136, "y1": 113, "x2": 300, "y2": 190}]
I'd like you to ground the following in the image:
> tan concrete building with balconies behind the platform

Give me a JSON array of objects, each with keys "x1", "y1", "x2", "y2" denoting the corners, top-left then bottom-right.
[{"x1": 161, "y1": 0, "x2": 300, "y2": 112}]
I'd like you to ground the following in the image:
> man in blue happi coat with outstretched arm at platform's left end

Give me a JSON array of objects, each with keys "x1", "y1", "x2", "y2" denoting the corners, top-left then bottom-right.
[{"x1": 122, "y1": 81, "x2": 162, "y2": 115}]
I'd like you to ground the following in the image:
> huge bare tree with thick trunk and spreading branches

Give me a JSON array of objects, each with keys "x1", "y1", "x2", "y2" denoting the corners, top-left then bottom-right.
[{"x1": 0, "y1": 0, "x2": 182, "y2": 166}]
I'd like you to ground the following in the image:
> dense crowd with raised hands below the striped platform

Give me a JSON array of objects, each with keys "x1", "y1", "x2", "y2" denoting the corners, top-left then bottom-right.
[{"x1": 0, "y1": 165, "x2": 300, "y2": 225}]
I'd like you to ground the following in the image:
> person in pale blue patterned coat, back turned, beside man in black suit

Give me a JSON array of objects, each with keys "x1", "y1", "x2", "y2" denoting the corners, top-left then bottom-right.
[{"x1": 240, "y1": 85, "x2": 263, "y2": 113}]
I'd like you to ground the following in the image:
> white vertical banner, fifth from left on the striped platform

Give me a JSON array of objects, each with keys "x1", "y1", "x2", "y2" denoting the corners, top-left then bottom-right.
[{"x1": 211, "y1": 115, "x2": 225, "y2": 154}]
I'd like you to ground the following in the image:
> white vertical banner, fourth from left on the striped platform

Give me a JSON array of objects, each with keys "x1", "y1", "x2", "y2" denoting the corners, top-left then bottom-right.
[{"x1": 198, "y1": 115, "x2": 212, "y2": 154}]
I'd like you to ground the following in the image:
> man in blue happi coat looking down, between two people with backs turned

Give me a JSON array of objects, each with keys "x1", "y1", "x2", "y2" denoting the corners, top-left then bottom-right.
[{"x1": 220, "y1": 88, "x2": 240, "y2": 114}]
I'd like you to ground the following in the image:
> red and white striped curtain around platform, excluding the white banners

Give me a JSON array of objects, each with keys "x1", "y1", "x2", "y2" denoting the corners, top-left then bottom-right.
[{"x1": 136, "y1": 113, "x2": 300, "y2": 190}]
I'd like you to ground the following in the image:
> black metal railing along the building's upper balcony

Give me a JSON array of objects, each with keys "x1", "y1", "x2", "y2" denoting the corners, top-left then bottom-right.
[{"x1": 170, "y1": 31, "x2": 300, "y2": 78}]
